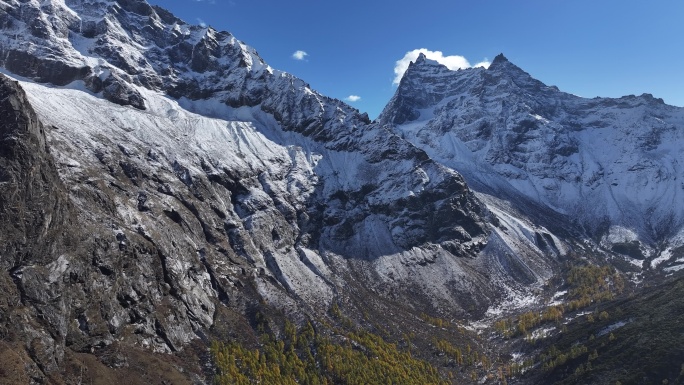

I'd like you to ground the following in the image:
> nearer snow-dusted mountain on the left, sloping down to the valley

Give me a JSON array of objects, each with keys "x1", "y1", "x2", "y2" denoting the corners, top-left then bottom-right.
[{"x1": 0, "y1": 0, "x2": 564, "y2": 381}]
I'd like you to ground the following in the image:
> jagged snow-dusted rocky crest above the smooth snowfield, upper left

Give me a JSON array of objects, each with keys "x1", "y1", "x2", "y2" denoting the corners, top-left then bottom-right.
[{"x1": 0, "y1": 0, "x2": 369, "y2": 135}]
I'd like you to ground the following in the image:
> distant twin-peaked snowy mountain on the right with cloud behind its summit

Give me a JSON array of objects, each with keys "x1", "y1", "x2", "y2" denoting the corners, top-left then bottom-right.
[{"x1": 379, "y1": 55, "x2": 684, "y2": 254}]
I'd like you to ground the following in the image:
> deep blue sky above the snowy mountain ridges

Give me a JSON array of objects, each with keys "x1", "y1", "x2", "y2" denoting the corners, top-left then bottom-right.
[{"x1": 151, "y1": 0, "x2": 684, "y2": 119}]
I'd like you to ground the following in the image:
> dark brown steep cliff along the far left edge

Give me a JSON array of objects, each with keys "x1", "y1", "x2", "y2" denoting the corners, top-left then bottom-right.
[{"x1": 0, "y1": 76, "x2": 74, "y2": 377}]
